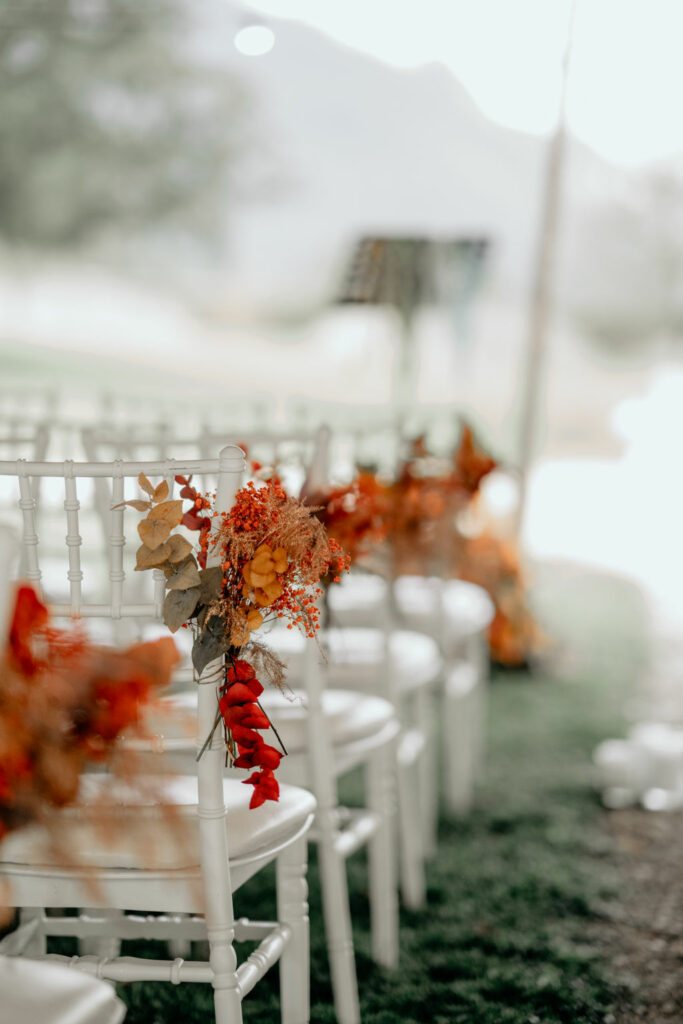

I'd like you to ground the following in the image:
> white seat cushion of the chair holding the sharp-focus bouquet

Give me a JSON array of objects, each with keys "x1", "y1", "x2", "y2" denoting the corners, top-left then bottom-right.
[{"x1": 0, "y1": 773, "x2": 315, "y2": 873}]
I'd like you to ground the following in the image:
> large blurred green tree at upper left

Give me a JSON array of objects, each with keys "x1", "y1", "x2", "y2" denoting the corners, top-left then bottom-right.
[{"x1": 0, "y1": 0, "x2": 245, "y2": 249}]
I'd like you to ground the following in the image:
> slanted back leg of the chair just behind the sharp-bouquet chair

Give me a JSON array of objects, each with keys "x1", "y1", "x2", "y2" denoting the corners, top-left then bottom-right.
[{"x1": 316, "y1": 810, "x2": 360, "y2": 1024}]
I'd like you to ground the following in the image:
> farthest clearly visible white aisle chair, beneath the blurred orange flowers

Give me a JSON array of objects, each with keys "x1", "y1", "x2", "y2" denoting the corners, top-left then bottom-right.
[{"x1": 288, "y1": 407, "x2": 495, "y2": 823}]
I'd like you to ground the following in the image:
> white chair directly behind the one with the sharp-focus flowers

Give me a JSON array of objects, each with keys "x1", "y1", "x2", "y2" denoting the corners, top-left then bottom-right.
[{"x1": 98, "y1": 430, "x2": 399, "y2": 1024}]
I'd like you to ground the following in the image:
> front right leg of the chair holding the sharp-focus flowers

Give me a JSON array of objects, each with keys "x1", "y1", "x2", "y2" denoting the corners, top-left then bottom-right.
[{"x1": 276, "y1": 836, "x2": 310, "y2": 1024}]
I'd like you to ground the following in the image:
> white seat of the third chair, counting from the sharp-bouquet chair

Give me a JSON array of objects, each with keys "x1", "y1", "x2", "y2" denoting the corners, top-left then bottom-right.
[{"x1": 325, "y1": 629, "x2": 442, "y2": 693}]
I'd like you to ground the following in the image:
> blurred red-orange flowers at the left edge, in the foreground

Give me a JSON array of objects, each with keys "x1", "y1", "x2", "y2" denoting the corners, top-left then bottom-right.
[{"x1": 0, "y1": 586, "x2": 179, "y2": 839}]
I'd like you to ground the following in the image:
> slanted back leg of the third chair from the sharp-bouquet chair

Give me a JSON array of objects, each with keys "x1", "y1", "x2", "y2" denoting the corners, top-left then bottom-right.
[{"x1": 396, "y1": 733, "x2": 426, "y2": 910}]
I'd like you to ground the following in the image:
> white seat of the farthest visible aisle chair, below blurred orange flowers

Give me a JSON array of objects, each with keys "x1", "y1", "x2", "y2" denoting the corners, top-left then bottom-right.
[{"x1": 394, "y1": 575, "x2": 495, "y2": 640}]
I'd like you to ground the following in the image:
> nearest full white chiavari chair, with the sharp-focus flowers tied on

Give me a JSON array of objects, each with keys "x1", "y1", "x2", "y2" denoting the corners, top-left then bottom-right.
[{"x1": 0, "y1": 445, "x2": 315, "y2": 1024}]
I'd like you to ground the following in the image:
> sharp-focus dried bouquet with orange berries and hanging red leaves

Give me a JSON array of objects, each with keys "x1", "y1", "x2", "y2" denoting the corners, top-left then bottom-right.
[{"x1": 124, "y1": 475, "x2": 348, "y2": 807}]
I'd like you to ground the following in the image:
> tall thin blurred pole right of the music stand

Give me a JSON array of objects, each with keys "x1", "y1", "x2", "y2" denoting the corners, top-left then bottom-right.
[{"x1": 515, "y1": 0, "x2": 577, "y2": 538}]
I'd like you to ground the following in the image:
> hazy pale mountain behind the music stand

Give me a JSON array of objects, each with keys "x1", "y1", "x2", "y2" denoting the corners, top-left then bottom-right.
[{"x1": 203, "y1": 5, "x2": 625, "y2": 315}]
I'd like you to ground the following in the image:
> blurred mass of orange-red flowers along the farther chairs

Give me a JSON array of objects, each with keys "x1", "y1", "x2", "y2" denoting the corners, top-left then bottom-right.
[{"x1": 310, "y1": 424, "x2": 540, "y2": 666}]
